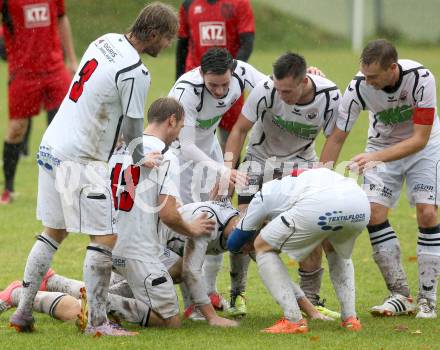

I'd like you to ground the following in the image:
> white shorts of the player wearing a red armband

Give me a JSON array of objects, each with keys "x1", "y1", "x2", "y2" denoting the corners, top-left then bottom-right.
[{"x1": 364, "y1": 144, "x2": 440, "y2": 208}]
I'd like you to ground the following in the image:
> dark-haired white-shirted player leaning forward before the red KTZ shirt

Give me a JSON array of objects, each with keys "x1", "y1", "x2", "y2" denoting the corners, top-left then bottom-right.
[{"x1": 169, "y1": 48, "x2": 265, "y2": 314}]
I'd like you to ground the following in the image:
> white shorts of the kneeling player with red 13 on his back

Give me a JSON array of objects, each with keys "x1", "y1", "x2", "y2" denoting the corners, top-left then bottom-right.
[{"x1": 113, "y1": 256, "x2": 179, "y2": 319}]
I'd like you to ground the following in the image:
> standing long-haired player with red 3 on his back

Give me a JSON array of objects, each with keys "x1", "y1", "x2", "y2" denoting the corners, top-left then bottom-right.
[{"x1": 10, "y1": 3, "x2": 178, "y2": 335}]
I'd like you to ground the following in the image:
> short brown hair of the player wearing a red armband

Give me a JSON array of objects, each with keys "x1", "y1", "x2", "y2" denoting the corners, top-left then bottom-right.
[{"x1": 361, "y1": 39, "x2": 399, "y2": 69}]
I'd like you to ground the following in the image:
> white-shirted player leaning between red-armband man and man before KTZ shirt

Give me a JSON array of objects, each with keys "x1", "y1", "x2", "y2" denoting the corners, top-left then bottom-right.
[{"x1": 225, "y1": 52, "x2": 340, "y2": 317}]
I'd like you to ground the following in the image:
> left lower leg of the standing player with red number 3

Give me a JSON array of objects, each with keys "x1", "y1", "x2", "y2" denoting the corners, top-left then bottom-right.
[{"x1": 10, "y1": 233, "x2": 59, "y2": 332}]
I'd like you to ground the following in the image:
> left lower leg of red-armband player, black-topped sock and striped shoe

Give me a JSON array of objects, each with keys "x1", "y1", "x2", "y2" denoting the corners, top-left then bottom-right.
[{"x1": 367, "y1": 220, "x2": 416, "y2": 316}]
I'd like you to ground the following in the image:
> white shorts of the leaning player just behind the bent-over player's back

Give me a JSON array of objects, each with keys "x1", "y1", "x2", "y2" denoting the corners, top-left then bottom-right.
[{"x1": 236, "y1": 154, "x2": 318, "y2": 204}]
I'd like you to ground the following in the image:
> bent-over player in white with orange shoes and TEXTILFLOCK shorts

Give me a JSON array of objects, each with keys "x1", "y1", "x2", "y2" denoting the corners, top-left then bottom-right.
[{"x1": 227, "y1": 168, "x2": 370, "y2": 333}]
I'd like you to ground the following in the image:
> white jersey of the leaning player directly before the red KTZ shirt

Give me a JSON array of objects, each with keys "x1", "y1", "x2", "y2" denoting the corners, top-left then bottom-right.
[{"x1": 169, "y1": 60, "x2": 266, "y2": 155}]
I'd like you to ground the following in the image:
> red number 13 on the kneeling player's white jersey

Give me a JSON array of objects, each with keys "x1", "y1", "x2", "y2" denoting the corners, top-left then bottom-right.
[{"x1": 111, "y1": 163, "x2": 141, "y2": 212}]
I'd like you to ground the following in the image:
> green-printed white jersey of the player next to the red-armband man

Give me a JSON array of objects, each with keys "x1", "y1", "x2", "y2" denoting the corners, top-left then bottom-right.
[{"x1": 242, "y1": 75, "x2": 340, "y2": 161}]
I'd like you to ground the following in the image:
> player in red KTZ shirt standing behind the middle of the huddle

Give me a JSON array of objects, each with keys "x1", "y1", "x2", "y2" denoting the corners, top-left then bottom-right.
[{"x1": 176, "y1": 0, "x2": 255, "y2": 149}]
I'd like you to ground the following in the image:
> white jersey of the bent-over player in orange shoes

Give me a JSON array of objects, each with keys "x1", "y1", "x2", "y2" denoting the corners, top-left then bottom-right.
[{"x1": 237, "y1": 168, "x2": 359, "y2": 231}]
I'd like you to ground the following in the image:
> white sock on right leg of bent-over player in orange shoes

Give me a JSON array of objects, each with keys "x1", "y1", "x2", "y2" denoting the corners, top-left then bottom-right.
[{"x1": 327, "y1": 252, "x2": 356, "y2": 320}]
